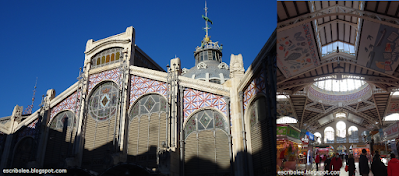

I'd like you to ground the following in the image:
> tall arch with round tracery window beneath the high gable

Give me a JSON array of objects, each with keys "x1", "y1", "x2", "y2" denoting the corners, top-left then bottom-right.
[{"x1": 82, "y1": 80, "x2": 120, "y2": 172}]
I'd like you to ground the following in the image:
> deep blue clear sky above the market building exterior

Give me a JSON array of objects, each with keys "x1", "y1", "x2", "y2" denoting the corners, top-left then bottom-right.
[{"x1": 0, "y1": 0, "x2": 277, "y2": 117}]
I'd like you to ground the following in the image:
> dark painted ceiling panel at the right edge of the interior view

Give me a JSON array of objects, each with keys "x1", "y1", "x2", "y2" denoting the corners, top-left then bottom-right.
[{"x1": 357, "y1": 20, "x2": 399, "y2": 74}]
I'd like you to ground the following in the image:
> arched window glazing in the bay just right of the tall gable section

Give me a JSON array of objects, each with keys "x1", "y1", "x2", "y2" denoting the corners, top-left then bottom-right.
[{"x1": 129, "y1": 94, "x2": 167, "y2": 120}]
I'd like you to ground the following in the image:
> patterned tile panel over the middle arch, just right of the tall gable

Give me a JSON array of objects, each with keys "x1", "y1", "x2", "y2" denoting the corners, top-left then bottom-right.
[{"x1": 130, "y1": 75, "x2": 168, "y2": 105}]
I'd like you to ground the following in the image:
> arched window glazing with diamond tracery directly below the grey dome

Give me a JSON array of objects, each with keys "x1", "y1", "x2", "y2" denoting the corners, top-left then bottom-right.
[{"x1": 184, "y1": 109, "x2": 229, "y2": 138}]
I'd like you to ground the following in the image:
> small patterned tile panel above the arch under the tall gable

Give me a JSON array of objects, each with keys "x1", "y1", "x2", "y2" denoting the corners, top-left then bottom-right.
[{"x1": 89, "y1": 68, "x2": 121, "y2": 92}]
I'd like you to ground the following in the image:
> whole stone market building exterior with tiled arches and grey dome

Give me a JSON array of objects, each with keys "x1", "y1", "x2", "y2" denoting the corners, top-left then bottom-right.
[{"x1": 0, "y1": 21, "x2": 276, "y2": 175}]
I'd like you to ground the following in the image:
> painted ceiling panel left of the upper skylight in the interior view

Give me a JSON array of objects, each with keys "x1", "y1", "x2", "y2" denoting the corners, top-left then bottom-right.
[{"x1": 277, "y1": 23, "x2": 319, "y2": 78}]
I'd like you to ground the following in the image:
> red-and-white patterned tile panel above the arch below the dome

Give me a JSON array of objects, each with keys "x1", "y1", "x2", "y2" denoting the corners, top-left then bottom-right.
[{"x1": 183, "y1": 88, "x2": 227, "y2": 120}]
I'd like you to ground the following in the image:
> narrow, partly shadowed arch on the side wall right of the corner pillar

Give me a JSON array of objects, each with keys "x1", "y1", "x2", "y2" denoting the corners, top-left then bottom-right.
[{"x1": 245, "y1": 93, "x2": 268, "y2": 175}]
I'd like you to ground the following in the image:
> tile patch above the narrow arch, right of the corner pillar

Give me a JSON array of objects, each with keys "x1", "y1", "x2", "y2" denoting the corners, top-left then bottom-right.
[{"x1": 244, "y1": 70, "x2": 266, "y2": 112}]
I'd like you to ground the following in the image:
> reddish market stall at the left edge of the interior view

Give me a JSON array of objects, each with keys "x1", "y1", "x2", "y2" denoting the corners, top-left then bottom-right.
[{"x1": 277, "y1": 124, "x2": 302, "y2": 170}]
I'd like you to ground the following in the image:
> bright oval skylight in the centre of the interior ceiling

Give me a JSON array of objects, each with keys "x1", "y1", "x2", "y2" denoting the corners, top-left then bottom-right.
[{"x1": 313, "y1": 79, "x2": 366, "y2": 92}]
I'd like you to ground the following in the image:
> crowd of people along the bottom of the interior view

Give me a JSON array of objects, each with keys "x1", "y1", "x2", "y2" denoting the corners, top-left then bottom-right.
[{"x1": 315, "y1": 149, "x2": 399, "y2": 176}]
